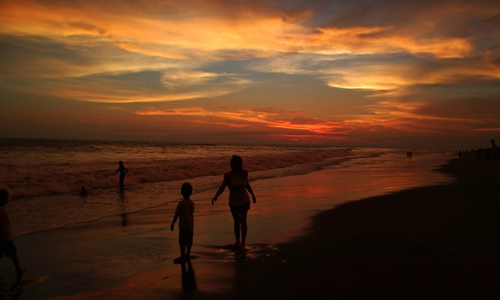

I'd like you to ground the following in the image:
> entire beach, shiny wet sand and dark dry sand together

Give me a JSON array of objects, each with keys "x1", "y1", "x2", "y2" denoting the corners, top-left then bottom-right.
[{"x1": 0, "y1": 154, "x2": 500, "y2": 299}]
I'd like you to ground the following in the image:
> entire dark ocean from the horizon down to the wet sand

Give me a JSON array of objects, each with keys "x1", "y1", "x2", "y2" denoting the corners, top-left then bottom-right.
[{"x1": 0, "y1": 139, "x2": 444, "y2": 235}]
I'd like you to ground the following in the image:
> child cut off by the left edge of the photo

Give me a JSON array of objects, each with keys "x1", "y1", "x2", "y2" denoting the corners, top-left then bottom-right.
[{"x1": 0, "y1": 190, "x2": 26, "y2": 278}]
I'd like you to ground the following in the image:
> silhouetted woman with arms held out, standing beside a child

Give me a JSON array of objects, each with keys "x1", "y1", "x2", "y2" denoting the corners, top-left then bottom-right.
[{"x1": 212, "y1": 155, "x2": 257, "y2": 249}]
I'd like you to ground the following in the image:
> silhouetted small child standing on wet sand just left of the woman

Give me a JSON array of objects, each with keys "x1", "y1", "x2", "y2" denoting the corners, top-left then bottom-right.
[{"x1": 170, "y1": 182, "x2": 194, "y2": 263}]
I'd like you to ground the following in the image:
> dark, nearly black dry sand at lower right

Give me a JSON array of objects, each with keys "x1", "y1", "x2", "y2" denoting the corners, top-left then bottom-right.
[{"x1": 221, "y1": 155, "x2": 500, "y2": 299}]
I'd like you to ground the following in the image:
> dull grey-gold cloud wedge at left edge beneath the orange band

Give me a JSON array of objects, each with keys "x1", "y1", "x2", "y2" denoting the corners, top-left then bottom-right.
[{"x1": 0, "y1": 35, "x2": 168, "y2": 78}]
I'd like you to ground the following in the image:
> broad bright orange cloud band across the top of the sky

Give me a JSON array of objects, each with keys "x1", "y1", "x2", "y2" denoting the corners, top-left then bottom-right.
[{"x1": 0, "y1": 0, "x2": 480, "y2": 60}]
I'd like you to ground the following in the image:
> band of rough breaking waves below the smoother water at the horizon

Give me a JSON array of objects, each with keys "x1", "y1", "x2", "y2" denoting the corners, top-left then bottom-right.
[{"x1": 0, "y1": 146, "x2": 352, "y2": 198}]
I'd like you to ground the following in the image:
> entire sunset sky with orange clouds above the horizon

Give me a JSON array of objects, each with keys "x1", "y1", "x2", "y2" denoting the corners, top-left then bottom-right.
[{"x1": 0, "y1": 0, "x2": 500, "y2": 148}]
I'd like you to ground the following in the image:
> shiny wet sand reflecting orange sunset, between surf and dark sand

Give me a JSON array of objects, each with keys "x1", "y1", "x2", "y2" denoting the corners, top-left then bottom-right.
[{"x1": 0, "y1": 151, "x2": 453, "y2": 299}]
